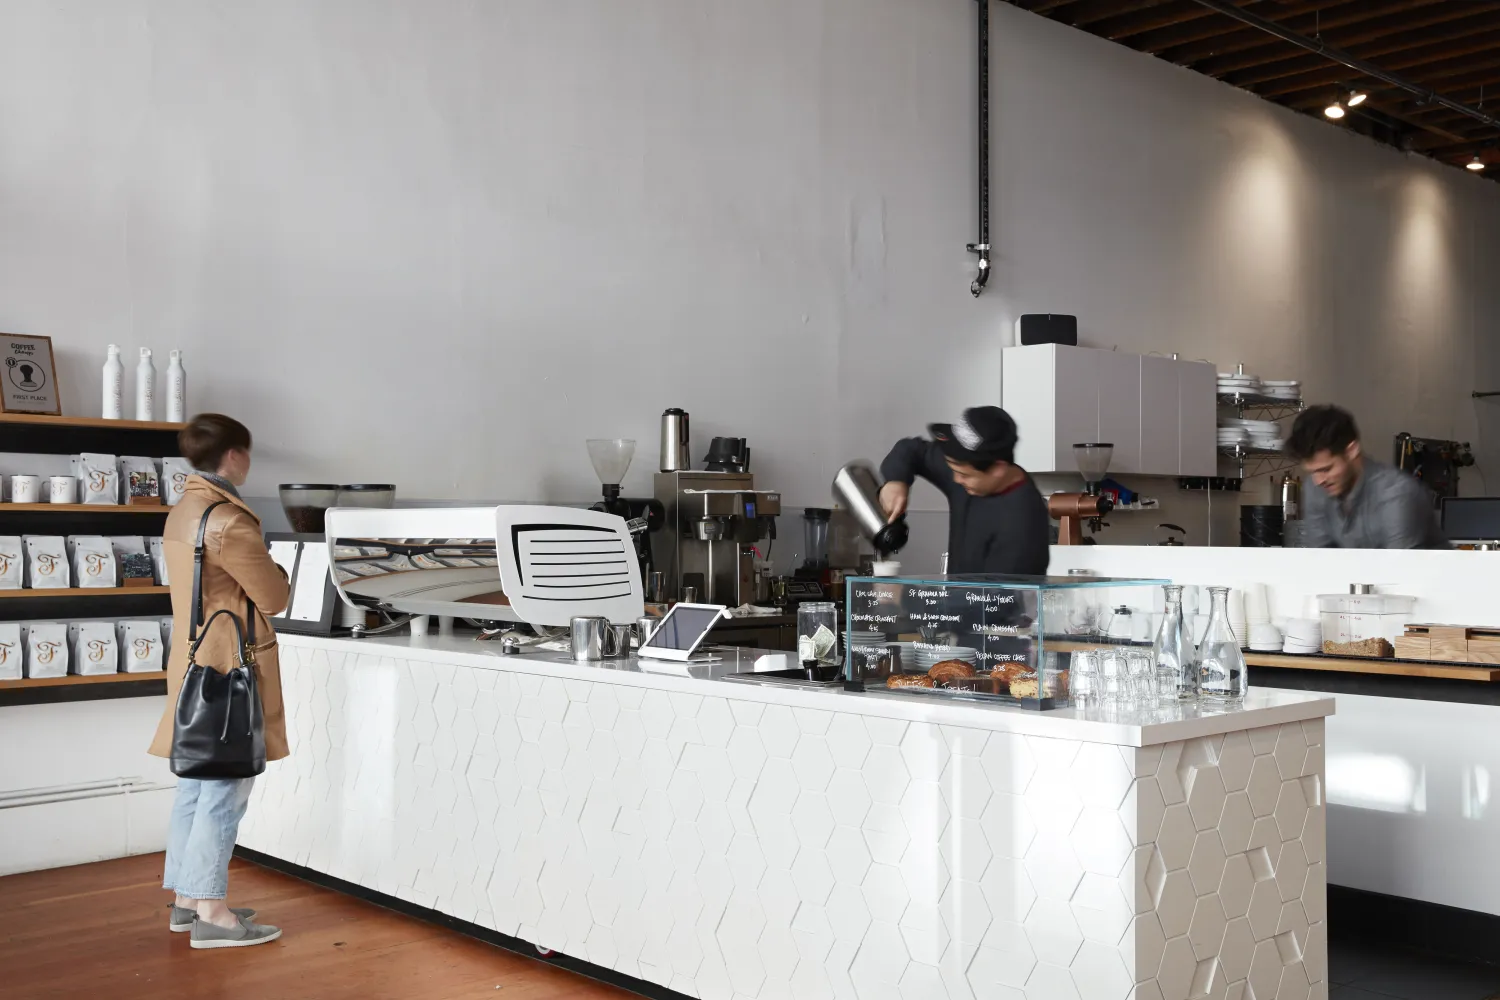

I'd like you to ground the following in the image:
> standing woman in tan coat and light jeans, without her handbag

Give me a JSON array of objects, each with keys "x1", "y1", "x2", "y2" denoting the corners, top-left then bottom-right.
[{"x1": 150, "y1": 414, "x2": 288, "y2": 948}]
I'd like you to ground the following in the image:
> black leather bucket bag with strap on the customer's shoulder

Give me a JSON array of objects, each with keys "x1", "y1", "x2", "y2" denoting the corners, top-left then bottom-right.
[{"x1": 171, "y1": 501, "x2": 266, "y2": 778}]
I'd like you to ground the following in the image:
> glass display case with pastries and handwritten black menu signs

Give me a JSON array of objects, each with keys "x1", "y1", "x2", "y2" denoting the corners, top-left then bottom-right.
[{"x1": 845, "y1": 576, "x2": 1166, "y2": 709}]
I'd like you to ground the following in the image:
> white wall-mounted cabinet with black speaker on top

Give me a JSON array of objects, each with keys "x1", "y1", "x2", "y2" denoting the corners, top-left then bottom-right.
[{"x1": 1001, "y1": 343, "x2": 1218, "y2": 475}]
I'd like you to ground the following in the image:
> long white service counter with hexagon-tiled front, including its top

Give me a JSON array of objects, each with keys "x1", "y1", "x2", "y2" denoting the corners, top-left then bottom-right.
[{"x1": 240, "y1": 636, "x2": 1332, "y2": 1000}]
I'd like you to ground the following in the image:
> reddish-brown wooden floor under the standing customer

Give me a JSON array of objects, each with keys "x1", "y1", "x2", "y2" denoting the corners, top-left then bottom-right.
[{"x1": 0, "y1": 855, "x2": 633, "y2": 1000}]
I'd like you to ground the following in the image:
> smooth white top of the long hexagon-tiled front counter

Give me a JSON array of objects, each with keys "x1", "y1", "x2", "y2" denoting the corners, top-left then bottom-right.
[{"x1": 279, "y1": 634, "x2": 1334, "y2": 747}]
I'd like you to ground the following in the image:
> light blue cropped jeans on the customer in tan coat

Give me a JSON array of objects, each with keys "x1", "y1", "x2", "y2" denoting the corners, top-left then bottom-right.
[{"x1": 162, "y1": 778, "x2": 255, "y2": 900}]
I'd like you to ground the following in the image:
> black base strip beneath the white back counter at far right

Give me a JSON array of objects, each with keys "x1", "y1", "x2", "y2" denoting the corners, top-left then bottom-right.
[{"x1": 1328, "y1": 886, "x2": 1500, "y2": 966}]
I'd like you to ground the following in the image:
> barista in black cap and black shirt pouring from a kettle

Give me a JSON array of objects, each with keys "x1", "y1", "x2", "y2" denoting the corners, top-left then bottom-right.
[{"x1": 881, "y1": 406, "x2": 1052, "y2": 576}]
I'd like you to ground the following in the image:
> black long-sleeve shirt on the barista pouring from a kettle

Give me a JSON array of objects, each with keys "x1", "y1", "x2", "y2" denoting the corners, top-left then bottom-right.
[{"x1": 881, "y1": 438, "x2": 1052, "y2": 576}]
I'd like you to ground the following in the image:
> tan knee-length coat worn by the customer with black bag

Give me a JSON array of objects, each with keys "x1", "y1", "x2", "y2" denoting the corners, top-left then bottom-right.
[{"x1": 150, "y1": 475, "x2": 290, "y2": 760}]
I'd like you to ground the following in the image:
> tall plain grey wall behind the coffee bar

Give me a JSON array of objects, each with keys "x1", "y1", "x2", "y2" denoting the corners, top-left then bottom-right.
[{"x1": 0, "y1": 0, "x2": 1500, "y2": 563}]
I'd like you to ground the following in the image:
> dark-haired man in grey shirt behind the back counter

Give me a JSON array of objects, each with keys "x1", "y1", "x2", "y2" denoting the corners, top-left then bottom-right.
[{"x1": 1287, "y1": 406, "x2": 1449, "y2": 549}]
